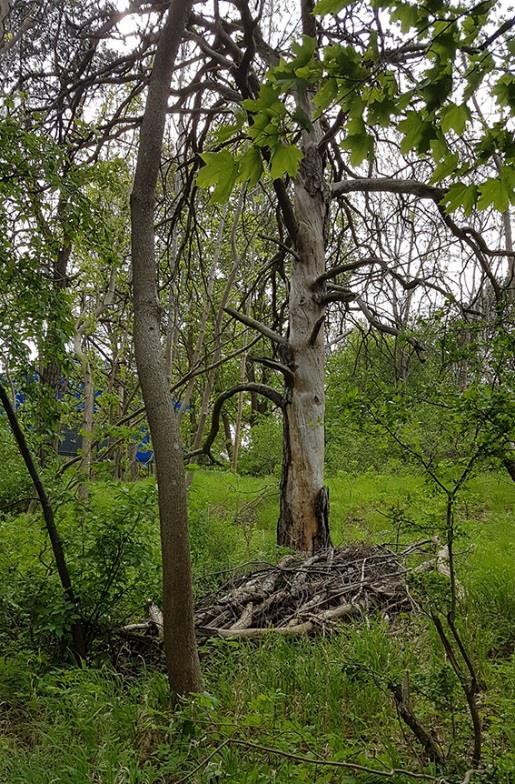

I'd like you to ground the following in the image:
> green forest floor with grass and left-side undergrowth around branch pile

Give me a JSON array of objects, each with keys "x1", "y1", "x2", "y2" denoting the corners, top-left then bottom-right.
[{"x1": 0, "y1": 469, "x2": 515, "y2": 784}]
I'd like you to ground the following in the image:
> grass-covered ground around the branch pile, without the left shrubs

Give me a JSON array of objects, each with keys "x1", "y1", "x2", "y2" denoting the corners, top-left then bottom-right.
[{"x1": 0, "y1": 470, "x2": 515, "y2": 784}]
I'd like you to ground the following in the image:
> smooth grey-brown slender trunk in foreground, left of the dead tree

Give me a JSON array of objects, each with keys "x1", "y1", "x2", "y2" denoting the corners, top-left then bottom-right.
[{"x1": 131, "y1": 0, "x2": 200, "y2": 694}]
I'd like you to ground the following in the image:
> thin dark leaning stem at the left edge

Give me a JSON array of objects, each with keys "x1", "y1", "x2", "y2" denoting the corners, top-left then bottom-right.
[{"x1": 0, "y1": 384, "x2": 86, "y2": 663}]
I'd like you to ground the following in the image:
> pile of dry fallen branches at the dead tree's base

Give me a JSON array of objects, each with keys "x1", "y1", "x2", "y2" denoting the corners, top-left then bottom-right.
[{"x1": 123, "y1": 542, "x2": 432, "y2": 640}]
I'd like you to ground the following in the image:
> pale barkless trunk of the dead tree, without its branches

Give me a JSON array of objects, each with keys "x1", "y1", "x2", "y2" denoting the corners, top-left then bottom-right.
[{"x1": 277, "y1": 59, "x2": 330, "y2": 552}]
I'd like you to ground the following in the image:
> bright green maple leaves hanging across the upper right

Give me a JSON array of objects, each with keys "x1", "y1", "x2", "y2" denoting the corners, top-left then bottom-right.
[{"x1": 198, "y1": 0, "x2": 515, "y2": 214}]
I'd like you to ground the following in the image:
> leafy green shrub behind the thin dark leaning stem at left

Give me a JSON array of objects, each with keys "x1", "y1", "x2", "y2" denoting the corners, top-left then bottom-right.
[{"x1": 0, "y1": 482, "x2": 160, "y2": 648}]
